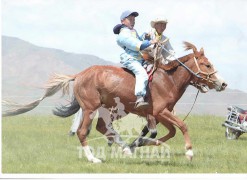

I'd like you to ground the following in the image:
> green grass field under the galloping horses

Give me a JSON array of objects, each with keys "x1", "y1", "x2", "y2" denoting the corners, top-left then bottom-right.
[{"x1": 2, "y1": 115, "x2": 247, "y2": 173}]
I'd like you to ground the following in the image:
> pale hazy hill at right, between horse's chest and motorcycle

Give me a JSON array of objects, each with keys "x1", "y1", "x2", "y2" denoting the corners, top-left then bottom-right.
[{"x1": 175, "y1": 87, "x2": 247, "y2": 116}]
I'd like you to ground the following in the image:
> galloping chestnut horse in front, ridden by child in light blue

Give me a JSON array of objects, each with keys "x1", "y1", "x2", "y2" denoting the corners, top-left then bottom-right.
[{"x1": 3, "y1": 42, "x2": 227, "y2": 163}]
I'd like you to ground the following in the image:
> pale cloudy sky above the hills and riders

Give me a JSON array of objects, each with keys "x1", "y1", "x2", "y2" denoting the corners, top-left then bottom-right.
[{"x1": 1, "y1": 0, "x2": 247, "y2": 92}]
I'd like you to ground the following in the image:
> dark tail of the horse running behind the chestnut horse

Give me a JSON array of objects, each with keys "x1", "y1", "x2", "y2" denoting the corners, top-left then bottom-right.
[{"x1": 53, "y1": 97, "x2": 80, "y2": 118}]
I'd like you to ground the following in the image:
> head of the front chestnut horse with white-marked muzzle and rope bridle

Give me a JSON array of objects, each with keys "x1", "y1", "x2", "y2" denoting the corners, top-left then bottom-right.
[{"x1": 184, "y1": 42, "x2": 227, "y2": 93}]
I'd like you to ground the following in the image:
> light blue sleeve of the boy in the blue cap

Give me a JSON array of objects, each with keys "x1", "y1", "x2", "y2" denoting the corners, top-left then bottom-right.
[{"x1": 117, "y1": 28, "x2": 142, "y2": 51}]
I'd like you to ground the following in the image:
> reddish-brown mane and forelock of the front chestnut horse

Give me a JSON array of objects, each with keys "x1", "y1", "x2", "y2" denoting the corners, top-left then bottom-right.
[{"x1": 158, "y1": 41, "x2": 197, "y2": 71}]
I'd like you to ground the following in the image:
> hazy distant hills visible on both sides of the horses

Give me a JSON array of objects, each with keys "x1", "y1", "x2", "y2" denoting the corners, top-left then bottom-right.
[{"x1": 2, "y1": 36, "x2": 247, "y2": 116}]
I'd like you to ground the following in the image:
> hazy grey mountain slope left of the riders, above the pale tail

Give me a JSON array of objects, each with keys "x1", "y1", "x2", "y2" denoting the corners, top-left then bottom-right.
[{"x1": 2, "y1": 36, "x2": 113, "y2": 96}]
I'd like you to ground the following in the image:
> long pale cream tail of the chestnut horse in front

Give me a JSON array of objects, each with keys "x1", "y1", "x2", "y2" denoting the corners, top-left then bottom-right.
[{"x1": 2, "y1": 74, "x2": 76, "y2": 117}]
